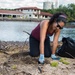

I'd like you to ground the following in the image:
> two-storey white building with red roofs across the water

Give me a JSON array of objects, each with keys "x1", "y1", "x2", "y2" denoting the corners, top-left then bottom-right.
[{"x1": 15, "y1": 7, "x2": 52, "y2": 19}]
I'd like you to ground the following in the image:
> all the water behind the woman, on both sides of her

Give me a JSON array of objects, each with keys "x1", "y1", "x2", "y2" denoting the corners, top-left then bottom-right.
[{"x1": 0, "y1": 21, "x2": 75, "y2": 41}]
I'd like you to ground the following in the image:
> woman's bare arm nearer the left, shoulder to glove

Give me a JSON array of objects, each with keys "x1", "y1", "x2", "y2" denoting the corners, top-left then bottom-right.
[{"x1": 40, "y1": 20, "x2": 49, "y2": 54}]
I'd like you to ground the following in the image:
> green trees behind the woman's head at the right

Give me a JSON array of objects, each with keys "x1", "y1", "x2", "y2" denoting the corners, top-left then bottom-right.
[{"x1": 42, "y1": 4, "x2": 75, "y2": 21}]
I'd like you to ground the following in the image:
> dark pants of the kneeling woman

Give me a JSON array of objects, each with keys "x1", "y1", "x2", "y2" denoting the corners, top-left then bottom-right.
[{"x1": 29, "y1": 36, "x2": 52, "y2": 57}]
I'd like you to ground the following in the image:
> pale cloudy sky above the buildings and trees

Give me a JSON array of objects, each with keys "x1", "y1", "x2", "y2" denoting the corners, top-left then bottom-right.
[{"x1": 0, "y1": 0, "x2": 75, "y2": 9}]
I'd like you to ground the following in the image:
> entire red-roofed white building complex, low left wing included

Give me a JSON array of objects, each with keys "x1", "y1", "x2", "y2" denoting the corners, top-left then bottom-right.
[{"x1": 0, "y1": 7, "x2": 52, "y2": 20}]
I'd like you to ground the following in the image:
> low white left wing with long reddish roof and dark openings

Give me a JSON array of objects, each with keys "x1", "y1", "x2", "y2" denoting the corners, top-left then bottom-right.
[{"x1": 0, "y1": 9, "x2": 23, "y2": 19}]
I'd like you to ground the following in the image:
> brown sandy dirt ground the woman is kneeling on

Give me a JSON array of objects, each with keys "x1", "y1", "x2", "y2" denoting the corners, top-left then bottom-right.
[{"x1": 0, "y1": 41, "x2": 75, "y2": 75}]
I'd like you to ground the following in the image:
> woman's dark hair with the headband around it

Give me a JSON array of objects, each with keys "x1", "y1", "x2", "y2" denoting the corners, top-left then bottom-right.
[{"x1": 49, "y1": 13, "x2": 67, "y2": 25}]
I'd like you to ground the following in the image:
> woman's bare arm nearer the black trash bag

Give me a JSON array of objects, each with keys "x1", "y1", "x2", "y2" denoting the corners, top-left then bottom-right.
[{"x1": 52, "y1": 29, "x2": 60, "y2": 54}]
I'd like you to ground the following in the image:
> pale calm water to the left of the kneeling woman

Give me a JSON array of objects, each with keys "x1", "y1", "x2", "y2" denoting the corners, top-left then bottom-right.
[{"x1": 0, "y1": 21, "x2": 38, "y2": 41}]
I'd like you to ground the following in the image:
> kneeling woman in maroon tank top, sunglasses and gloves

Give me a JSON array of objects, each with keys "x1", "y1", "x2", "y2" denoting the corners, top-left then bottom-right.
[{"x1": 29, "y1": 13, "x2": 66, "y2": 63}]
